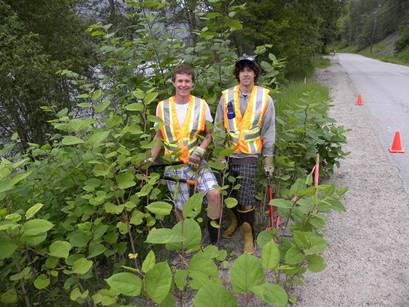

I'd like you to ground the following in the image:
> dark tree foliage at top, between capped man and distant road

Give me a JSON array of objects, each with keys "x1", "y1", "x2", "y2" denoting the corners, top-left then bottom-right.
[{"x1": 232, "y1": 0, "x2": 343, "y2": 76}]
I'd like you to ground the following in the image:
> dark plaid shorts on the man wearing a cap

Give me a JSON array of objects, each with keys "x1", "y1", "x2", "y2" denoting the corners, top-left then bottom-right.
[{"x1": 229, "y1": 157, "x2": 257, "y2": 210}]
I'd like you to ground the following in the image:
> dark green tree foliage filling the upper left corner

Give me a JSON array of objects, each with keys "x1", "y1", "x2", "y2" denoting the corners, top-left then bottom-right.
[{"x1": 0, "y1": 0, "x2": 93, "y2": 150}]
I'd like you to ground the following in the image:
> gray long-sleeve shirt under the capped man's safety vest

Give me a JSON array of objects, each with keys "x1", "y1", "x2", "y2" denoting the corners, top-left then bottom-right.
[{"x1": 214, "y1": 91, "x2": 275, "y2": 158}]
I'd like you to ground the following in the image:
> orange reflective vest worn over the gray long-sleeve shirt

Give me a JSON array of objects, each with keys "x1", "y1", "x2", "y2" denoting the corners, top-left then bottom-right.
[{"x1": 223, "y1": 85, "x2": 269, "y2": 154}]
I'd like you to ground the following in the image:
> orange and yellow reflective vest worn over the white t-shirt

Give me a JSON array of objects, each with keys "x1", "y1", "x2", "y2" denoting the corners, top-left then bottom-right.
[{"x1": 156, "y1": 96, "x2": 206, "y2": 163}]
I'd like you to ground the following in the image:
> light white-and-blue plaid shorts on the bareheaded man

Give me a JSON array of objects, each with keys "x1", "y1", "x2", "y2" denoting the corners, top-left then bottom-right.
[{"x1": 165, "y1": 162, "x2": 218, "y2": 211}]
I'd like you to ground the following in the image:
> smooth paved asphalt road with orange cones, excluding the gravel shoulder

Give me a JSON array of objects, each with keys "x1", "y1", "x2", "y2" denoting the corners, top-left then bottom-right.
[{"x1": 336, "y1": 53, "x2": 409, "y2": 191}]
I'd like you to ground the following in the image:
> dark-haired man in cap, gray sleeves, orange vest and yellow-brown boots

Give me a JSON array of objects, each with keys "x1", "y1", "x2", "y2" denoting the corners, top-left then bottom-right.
[{"x1": 215, "y1": 56, "x2": 275, "y2": 253}]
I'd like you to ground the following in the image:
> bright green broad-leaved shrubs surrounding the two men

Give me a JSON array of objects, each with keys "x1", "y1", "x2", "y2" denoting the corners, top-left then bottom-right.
[{"x1": 0, "y1": 1, "x2": 343, "y2": 306}]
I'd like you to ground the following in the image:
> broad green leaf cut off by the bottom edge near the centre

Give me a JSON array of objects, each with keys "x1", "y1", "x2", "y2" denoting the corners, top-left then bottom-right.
[{"x1": 193, "y1": 284, "x2": 238, "y2": 307}]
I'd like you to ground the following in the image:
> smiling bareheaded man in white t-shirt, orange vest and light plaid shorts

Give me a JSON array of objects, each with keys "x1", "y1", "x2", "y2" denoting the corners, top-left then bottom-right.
[{"x1": 151, "y1": 64, "x2": 221, "y2": 243}]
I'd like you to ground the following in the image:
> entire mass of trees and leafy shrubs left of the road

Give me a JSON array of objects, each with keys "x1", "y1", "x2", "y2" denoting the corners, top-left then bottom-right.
[{"x1": 0, "y1": 0, "x2": 406, "y2": 306}]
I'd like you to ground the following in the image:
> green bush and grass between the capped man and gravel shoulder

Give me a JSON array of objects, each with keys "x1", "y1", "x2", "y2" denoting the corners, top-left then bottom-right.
[{"x1": 275, "y1": 82, "x2": 346, "y2": 195}]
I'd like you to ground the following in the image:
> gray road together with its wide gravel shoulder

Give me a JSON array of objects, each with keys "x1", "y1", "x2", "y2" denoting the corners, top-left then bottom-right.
[{"x1": 295, "y1": 54, "x2": 409, "y2": 307}]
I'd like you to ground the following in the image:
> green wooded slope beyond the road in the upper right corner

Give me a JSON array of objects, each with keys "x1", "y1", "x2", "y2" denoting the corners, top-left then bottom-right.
[{"x1": 330, "y1": 0, "x2": 409, "y2": 65}]
